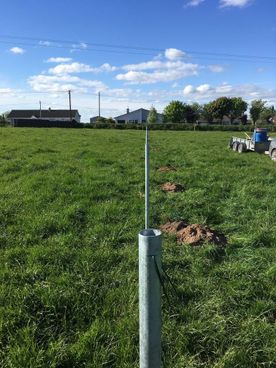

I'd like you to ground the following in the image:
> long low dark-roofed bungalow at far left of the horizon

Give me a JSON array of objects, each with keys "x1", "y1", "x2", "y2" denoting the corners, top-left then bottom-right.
[{"x1": 7, "y1": 108, "x2": 81, "y2": 126}]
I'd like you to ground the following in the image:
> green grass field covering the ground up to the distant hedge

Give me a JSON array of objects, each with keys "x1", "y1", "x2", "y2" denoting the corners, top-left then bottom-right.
[{"x1": 0, "y1": 128, "x2": 276, "y2": 368}]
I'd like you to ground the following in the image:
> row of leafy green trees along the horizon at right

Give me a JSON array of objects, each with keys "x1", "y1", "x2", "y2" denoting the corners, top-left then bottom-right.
[{"x1": 152, "y1": 97, "x2": 275, "y2": 125}]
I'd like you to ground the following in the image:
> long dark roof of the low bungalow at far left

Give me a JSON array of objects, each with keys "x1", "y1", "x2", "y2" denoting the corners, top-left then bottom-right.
[{"x1": 7, "y1": 109, "x2": 79, "y2": 119}]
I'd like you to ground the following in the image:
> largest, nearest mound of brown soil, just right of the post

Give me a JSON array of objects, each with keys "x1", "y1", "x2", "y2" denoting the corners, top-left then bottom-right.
[{"x1": 161, "y1": 221, "x2": 227, "y2": 246}]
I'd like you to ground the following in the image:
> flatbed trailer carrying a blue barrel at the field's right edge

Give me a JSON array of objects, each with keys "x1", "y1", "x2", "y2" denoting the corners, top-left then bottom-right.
[{"x1": 229, "y1": 128, "x2": 276, "y2": 161}]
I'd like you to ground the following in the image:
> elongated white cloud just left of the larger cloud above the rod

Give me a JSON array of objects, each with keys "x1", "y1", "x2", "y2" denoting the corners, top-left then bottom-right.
[{"x1": 48, "y1": 62, "x2": 117, "y2": 74}]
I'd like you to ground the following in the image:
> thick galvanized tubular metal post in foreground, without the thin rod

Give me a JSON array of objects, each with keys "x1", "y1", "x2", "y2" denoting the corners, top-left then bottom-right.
[{"x1": 139, "y1": 229, "x2": 162, "y2": 368}]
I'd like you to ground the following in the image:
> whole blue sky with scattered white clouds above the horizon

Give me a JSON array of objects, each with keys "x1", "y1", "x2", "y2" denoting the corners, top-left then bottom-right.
[{"x1": 0, "y1": 0, "x2": 276, "y2": 121}]
